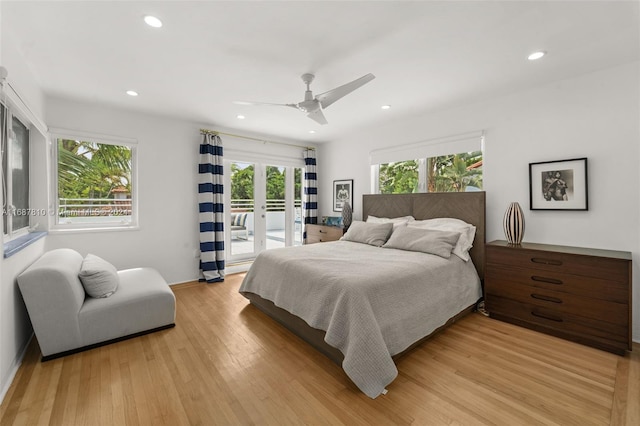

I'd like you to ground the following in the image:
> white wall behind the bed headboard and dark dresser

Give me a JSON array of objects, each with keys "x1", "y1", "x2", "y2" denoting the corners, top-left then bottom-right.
[{"x1": 318, "y1": 62, "x2": 640, "y2": 341}]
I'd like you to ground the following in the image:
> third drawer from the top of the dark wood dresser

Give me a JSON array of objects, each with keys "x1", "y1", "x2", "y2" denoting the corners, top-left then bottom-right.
[{"x1": 485, "y1": 285, "x2": 629, "y2": 324}]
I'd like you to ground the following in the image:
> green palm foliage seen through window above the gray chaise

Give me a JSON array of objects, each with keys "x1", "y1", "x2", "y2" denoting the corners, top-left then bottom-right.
[{"x1": 58, "y1": 139, "x2": 131, "y2": 198}]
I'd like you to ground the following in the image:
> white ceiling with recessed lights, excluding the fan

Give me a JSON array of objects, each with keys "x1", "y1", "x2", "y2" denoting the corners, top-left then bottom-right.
[{"x1": 0, "y1": 0, "x2": 640, "y2": 142}]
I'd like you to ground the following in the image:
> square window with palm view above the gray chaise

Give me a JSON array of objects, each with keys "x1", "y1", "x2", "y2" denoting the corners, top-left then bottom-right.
[{"x1": 54, "y1": 137, "x2": 137, "y2": 229}]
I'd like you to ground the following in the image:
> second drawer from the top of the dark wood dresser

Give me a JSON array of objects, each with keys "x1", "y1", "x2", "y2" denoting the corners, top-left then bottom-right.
[{"x1": 484, "y1": 265, "x2": 629, "y2": 303}]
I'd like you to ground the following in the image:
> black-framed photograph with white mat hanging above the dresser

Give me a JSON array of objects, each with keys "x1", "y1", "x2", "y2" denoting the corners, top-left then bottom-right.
[{"x1": 529, "y1": 158, "x2": 589, "y2": 210}]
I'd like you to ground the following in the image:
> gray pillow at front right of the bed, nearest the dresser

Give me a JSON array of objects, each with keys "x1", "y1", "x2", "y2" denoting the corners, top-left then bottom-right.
[{"x1": 382, "y1": 226, "x2": 460, "y2": 259}]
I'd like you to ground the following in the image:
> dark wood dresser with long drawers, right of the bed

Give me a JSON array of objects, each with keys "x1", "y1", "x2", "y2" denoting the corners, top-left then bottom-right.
[{"x1": 484, "y1": 241, "x2": 632, "y2": 355}]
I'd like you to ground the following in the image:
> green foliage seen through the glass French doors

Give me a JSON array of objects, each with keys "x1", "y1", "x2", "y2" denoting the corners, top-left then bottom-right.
[{"x1": 231, "y1": 163, "x2": 302, "y2": 211}]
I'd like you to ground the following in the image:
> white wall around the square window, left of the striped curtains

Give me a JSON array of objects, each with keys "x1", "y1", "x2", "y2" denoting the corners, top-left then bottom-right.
[{"x1": 46, "y1": 98, "x2": 310, "y2": 284}]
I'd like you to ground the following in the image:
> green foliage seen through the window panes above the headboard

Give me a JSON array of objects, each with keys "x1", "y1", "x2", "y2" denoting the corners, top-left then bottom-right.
[{"x1": 379, "y1": 151, "x2": 482, "y2": 194}]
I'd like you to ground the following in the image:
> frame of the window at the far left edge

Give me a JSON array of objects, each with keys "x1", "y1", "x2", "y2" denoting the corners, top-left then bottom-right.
[{"x1": 0, "y1": 102, "x2": 32, "y2": 243}]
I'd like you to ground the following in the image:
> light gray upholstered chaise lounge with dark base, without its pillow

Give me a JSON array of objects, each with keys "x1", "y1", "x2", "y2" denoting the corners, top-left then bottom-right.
[{"x1": 18, "y1": 249, "x2": 175, "y2": 361}]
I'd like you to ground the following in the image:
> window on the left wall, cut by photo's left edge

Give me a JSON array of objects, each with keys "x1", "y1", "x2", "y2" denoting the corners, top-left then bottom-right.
[{"x1": 0, "y1": 104, "x2": 32, "y2": 238}]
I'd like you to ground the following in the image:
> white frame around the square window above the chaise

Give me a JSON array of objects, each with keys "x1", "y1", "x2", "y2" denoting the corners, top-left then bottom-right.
[{"x1": 49, "y1": 129, "x2": 140, "y2": 233}]
